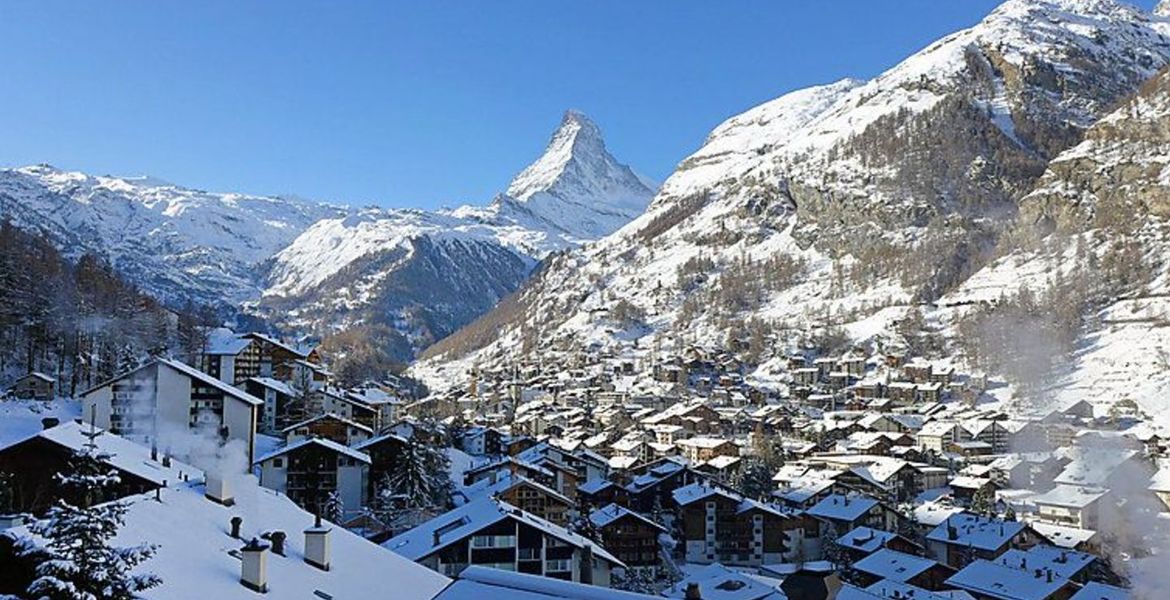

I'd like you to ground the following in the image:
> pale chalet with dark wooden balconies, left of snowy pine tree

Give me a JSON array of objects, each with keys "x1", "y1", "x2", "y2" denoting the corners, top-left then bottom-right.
[{"x1": 256, "y1": 437, "x2": 370, "y2": 515}]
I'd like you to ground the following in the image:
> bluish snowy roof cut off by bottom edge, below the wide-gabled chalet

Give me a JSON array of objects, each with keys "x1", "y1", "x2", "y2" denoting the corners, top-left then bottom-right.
[{"x1": 434, "y1": 565, "x2": 661, "y2": 600}]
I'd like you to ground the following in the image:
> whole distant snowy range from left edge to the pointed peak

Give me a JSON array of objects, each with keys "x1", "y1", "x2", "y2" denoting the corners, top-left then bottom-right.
[{"x1": 0, "y1": 111, "x2": 656, "y2": 360}]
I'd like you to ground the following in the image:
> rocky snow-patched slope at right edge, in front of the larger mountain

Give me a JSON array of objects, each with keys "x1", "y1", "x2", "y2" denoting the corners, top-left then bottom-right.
[{"x1": 942, "y1": 58, "x2": 1170, "y2": 426}]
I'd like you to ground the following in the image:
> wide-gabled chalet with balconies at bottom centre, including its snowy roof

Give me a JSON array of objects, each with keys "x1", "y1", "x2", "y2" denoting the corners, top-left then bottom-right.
[{"x1": 383, "y1": 498, "x2": 625, "y2": 587}]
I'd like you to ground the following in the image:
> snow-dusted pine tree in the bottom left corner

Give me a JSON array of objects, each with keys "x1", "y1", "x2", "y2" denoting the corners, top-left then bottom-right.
[{"x1": 21, "y1": 430, "x2": 161, "y2": 600}]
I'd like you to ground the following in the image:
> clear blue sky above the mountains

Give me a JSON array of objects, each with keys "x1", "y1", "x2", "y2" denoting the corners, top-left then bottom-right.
[{"x1": 0, "y1": 0, "x2": 1154, "y2": 207}]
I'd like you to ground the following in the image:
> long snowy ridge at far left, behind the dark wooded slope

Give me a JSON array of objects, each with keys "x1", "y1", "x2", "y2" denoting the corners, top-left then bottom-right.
[{"x1": 0, "y1": 165, "x2": 343, "y2": 305}]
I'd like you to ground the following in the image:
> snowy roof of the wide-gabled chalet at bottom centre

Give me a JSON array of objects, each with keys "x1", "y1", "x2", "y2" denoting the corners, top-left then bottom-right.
[{"x1": 381, "y1": 497, "x2": 625, "y2": 566}]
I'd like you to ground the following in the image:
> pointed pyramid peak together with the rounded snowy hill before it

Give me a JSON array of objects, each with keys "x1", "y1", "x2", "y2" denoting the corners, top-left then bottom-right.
[{"x1": 255, "y1": 111, "x2": 655, "y2": 359}]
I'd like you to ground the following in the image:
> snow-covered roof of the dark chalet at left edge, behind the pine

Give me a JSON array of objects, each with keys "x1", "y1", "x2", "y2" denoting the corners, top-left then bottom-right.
[{"x1": 8, "y1": 421, "x2": 204, "y2": 487}]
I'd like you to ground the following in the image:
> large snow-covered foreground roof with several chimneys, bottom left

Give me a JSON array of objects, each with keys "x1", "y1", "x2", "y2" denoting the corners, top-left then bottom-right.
[{"x1": 5, "y1": 476, "x2": 450, "y2": 600}]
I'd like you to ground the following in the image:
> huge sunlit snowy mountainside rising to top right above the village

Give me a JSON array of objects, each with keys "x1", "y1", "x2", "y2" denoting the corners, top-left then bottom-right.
[{"x1": 418, "y1": 0, "x2": 1170, "y2": 385}]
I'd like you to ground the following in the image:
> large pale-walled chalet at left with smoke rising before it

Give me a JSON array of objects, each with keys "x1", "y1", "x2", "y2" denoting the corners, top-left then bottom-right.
[{"x1": 80, "y1": 358, "x2": 264, "y2": 462}]
